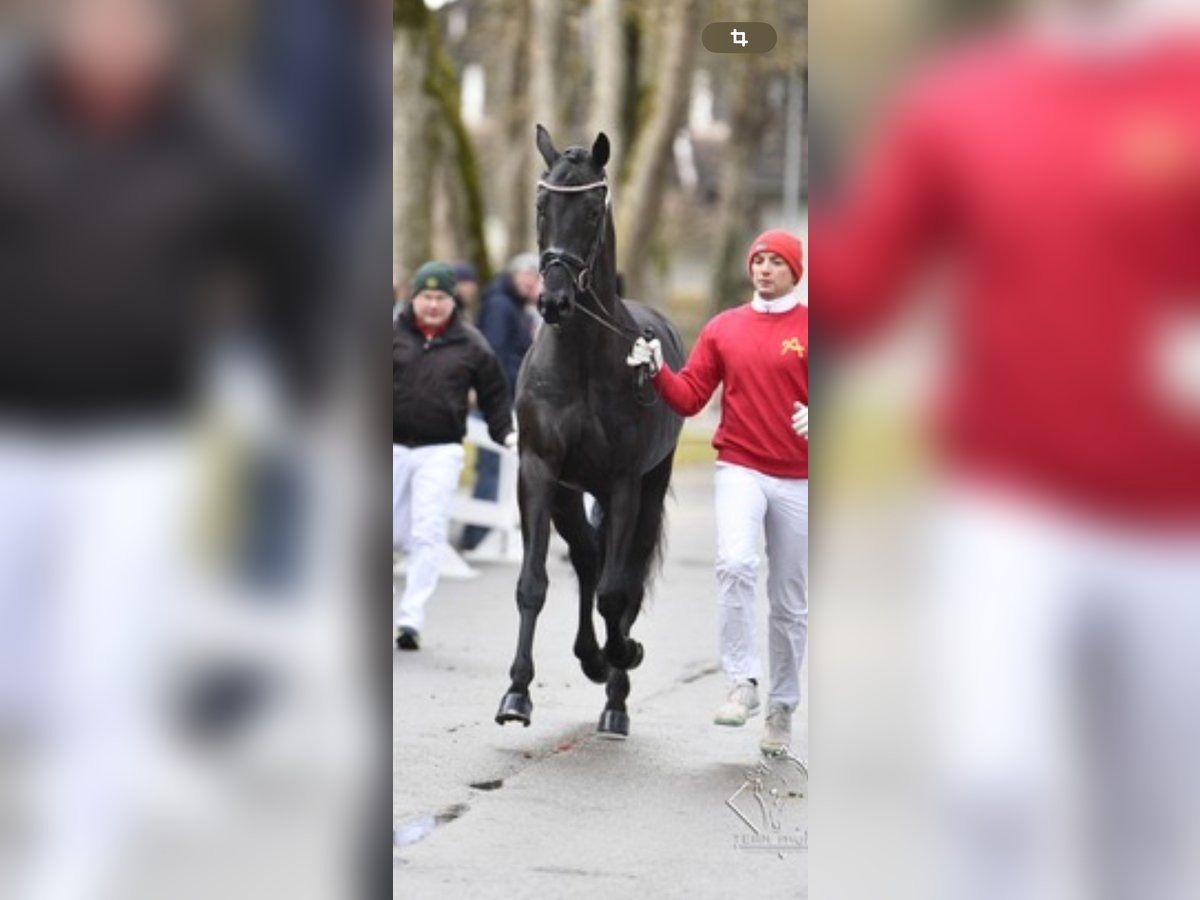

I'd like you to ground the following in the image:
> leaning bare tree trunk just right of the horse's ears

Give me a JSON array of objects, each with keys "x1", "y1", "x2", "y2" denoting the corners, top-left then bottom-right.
[{"x1": 617, "y1": 0, "x2": 700, "y2": 296}]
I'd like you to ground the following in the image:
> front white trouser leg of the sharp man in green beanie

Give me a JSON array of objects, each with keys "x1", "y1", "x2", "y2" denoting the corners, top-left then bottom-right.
[{"x1": 396, "y1": 444, "x2": 463, "y2": 631}]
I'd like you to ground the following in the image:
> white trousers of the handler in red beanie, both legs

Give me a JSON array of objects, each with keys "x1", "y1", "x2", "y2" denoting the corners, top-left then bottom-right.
[{"x1": 714, "y1": 463, "x2": 809, "y2": 709}]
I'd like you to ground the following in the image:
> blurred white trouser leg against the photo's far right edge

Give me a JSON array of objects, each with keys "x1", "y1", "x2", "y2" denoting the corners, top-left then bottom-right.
[{"x1": 1082, "y1": 535, "x2": 1200, "y2": 900}]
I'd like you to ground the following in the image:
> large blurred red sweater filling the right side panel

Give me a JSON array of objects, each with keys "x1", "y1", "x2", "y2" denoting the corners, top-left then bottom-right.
[{"x1": 810, "y1": 37, "x2": 1200, "y2": 521}]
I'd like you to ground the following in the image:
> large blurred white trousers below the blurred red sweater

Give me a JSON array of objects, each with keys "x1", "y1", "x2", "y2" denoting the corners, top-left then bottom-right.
[{"x1": 932, "y1": 491, "x2": 1200, "y2": 900}]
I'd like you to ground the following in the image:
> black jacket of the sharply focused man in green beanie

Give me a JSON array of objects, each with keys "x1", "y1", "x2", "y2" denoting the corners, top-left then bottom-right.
[{"x1": 391, "y1": 305, "x2": 512, "y2": 446}]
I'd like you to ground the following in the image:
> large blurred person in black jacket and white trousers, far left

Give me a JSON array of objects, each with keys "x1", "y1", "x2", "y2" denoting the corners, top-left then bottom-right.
[{"x1": 0, "y1": 0, "x2": 364, "y2": 898}]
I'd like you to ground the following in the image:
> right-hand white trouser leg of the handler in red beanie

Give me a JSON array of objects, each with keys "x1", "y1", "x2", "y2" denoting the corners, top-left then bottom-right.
[{"x1": 762, "y1": 475, "x2": 809, "y2": 710}]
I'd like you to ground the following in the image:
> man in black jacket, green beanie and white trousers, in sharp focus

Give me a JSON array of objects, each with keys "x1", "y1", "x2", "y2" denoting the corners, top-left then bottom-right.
[{"x1": 391, "y1": 263, "x2": 516, "y2": 650}]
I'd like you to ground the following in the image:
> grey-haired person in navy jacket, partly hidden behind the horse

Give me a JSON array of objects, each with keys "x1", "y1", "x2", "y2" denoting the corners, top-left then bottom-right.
[{"x1": 460, "y1": 253, "x2": 541, "y2": 551}]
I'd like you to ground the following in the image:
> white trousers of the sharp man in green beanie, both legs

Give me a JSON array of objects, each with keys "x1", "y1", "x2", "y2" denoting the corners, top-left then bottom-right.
[{"x1": 391, "y1": 444, "x2": 463, "y2": 631}]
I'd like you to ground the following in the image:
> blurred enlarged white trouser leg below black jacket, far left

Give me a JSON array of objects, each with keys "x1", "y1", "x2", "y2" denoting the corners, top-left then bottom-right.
[{"x1": 26, "y1": 434, "x2": 193, "y2": 900}]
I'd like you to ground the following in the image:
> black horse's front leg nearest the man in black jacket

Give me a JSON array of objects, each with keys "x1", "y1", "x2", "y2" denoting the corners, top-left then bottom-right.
[{"x1": 496, "y1": 454, "x2": 554, "y2": 727}]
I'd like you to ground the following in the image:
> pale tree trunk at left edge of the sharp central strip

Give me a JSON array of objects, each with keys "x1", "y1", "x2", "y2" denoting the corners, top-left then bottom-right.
[{"x1": 391, "y1": 0, "x2": 437, "y2": 280}]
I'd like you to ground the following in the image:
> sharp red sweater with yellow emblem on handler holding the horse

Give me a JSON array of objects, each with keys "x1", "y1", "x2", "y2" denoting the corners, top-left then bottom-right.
[{"x1": 654, "y1": 304, "x2": 809, "y2": 478}]
